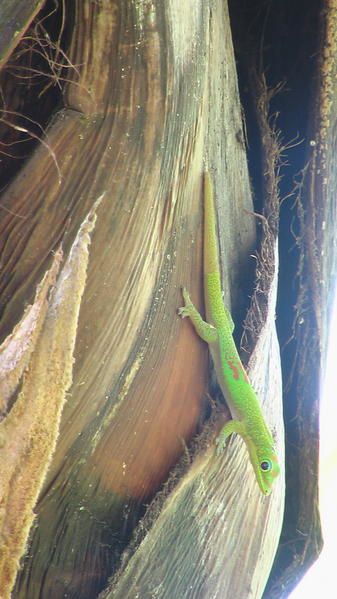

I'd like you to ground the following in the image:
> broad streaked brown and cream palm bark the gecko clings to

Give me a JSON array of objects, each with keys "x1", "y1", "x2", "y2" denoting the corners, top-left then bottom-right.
[{"x1": 0, "y1": 0, "x2": 284, "y2": 599}]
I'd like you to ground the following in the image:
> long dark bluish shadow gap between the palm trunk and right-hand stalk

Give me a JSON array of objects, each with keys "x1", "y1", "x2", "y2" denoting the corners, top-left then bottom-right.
[{"x1": 229, "y1": 0, "x2": 323, "y2": 599}]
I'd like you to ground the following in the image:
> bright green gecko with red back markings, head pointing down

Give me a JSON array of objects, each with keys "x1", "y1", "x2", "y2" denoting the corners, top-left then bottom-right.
[{"x1": 179, "y1": 172, "x2": 280, "y2": 495}]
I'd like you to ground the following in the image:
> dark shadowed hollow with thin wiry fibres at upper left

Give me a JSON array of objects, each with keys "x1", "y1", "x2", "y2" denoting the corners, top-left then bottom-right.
[{"x1": 0, "y1": 0, "x2": 76, "y2": 191}]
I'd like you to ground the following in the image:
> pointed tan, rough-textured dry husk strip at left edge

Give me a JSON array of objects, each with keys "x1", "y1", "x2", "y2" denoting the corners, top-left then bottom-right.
[{"x1": 0, "y1": 196, "x2": 102, "y2": 599}]
